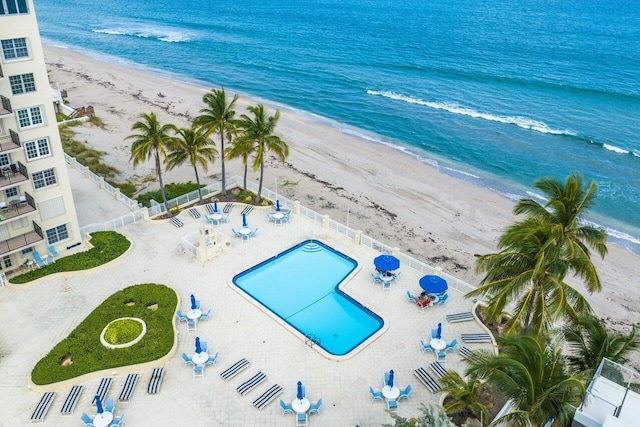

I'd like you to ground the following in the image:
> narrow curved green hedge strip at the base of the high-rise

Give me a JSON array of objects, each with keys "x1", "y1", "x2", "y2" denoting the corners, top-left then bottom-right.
[{"x1": 10, "y1": 231, "x2": 131, "y2": 284}]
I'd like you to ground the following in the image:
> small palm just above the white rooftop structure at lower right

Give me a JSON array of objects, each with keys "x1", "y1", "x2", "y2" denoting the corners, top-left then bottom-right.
[{"x1": 563, "y1": 315, "x2": 640, "y2": 378}]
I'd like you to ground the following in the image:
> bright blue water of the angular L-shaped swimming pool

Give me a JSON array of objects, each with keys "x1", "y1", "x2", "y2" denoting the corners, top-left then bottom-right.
[{"x1": 233, "y1": 240, "x2": 384, "y2": 356}]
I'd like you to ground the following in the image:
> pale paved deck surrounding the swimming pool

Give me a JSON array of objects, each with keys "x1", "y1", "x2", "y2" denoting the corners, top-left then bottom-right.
[{"x1": 0, "y1": 170, "x2": 492, "y2": 427}]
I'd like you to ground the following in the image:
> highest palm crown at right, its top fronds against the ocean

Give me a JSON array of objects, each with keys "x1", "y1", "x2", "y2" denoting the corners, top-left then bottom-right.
[{"x1": 514, "y1": 172, "x2": 607, "y2": 292}]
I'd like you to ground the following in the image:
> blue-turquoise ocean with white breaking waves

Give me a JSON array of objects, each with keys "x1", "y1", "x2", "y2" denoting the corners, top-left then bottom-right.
[{"x1": 36, "y1": 0, "x2": 640, "y2": 254}]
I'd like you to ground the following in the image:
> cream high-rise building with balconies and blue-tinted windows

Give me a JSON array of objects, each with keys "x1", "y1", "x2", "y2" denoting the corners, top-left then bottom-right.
[{"x1": 0, "y1": 0, "x2": 80, "y2": 272}]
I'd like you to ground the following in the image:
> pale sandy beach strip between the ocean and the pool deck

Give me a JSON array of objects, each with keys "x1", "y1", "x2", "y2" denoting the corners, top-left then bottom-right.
[{"x1": 45, "y1": 46, "x2": 640, "y2": 370}]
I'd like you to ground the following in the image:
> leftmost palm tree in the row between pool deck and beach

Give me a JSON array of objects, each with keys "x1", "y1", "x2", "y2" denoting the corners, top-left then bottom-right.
[{"x1": 125, "y1": 112, "x2": 176, "y2": 216}]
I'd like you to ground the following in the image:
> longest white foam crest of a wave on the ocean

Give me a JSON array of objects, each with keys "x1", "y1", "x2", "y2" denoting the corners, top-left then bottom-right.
[{"x1": 367, "y1": 90, "x2": 576, "y2": 136}]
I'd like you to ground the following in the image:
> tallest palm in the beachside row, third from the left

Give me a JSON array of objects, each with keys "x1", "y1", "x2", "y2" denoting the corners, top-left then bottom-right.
[{"x1": 194, "y1": 88, "x2": 238, "y2": 196}]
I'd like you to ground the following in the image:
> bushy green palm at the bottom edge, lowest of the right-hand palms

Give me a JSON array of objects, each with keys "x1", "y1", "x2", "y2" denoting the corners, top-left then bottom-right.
[{"x1": 466, "y1": 334, "x2": 584, "y2": 426}]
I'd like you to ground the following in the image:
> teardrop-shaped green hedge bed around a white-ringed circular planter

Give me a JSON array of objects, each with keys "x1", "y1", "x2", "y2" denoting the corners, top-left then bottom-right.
[{"x1": 31, "y1": 283, "x2": 178, "y2": 385}]
